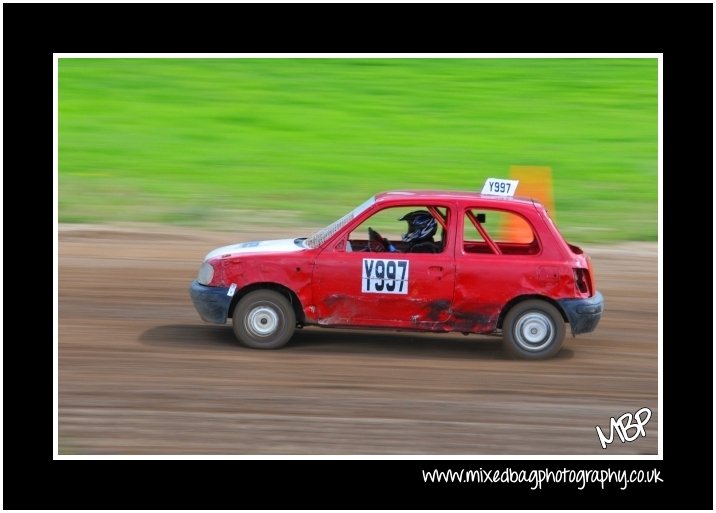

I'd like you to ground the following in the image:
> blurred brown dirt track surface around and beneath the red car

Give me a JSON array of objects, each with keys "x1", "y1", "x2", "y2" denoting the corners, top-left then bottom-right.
[{"x1": 59, "y1": 226, "x2": 659, "y2": 456}]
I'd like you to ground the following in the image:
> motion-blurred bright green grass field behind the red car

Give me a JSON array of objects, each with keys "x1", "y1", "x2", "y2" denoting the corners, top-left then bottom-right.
[{"x1": 58, "y1": 58, "x2": 657, "y2": 242}]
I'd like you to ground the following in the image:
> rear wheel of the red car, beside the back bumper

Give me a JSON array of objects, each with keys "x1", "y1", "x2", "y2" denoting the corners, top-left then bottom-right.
[{"x1": 502, "y1": 299, "x2": 565, "y2": 360}]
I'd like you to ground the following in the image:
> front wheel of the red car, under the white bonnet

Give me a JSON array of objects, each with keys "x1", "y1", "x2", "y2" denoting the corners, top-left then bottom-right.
[{"x1": 232, "y1": 290, "x2": 296, "y2": 349}]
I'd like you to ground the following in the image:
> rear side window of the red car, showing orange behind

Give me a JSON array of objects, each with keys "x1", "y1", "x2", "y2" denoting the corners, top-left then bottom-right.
[{"x1": 463, "y1": 208, "x2": 540, "y2": 255}]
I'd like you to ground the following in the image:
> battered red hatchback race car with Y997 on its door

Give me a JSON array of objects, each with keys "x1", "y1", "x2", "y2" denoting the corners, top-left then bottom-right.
[{"x1": 191, "y1": 186, "x2": 603, "y2": 359}]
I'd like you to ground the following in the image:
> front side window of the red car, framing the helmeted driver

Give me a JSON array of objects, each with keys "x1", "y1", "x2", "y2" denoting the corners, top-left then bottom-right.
[{"x1": 347, "y1": 205, "x2": 448, "y2": 253}]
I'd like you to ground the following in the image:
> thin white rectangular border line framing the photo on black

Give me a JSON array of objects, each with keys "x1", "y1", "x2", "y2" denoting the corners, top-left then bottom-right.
[{"x1": 52, "y1": 53, "x2": 664, "y2": 461}]
